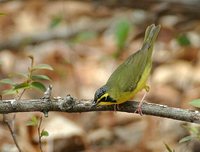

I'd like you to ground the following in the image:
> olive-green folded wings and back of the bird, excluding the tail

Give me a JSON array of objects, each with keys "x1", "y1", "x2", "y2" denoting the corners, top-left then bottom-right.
[{"x1": 107, "y1": 48, "x2": 148, "y2": 92}]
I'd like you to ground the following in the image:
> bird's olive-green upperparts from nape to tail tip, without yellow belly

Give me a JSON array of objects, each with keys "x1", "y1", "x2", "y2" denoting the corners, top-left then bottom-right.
[{"x1": 106, "y1": 25, "x2": 160, "y2": 93}]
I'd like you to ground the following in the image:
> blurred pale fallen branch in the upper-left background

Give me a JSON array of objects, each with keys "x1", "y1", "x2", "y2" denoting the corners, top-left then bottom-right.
[{"x1": 0, "y1": 18, "x2": 113, "y2": 51}]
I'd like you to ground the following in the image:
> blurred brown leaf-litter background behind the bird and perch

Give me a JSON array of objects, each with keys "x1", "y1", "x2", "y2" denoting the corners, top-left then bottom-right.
[{"x1": 0, "y1": 0, "x2": 200, "y2": 152}]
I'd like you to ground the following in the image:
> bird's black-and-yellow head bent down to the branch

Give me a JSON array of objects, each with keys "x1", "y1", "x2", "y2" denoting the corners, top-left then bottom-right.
[{"x1": 92, "y1": 85, "x2": 116, "y2": 106}]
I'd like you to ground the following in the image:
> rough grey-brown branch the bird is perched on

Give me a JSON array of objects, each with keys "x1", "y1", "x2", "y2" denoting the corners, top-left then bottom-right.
[{"x1": 0, "y1": 95, "x2": 200, "y2": 124}]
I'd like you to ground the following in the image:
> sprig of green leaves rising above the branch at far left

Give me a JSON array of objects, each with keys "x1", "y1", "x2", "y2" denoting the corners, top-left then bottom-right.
[{"x1": 0, "y1": 56, "x2": 53, "y2": 95}]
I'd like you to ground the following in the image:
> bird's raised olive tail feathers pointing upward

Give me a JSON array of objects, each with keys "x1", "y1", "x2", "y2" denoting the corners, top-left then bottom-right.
[{"x1": 141, "y1": 24, "x2": 161, "y2": 57}]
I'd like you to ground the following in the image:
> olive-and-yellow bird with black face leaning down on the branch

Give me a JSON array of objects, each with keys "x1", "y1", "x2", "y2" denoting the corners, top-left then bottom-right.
[{"x1": 92, "y1": 24, "x2": 161, "y2": 115}]
